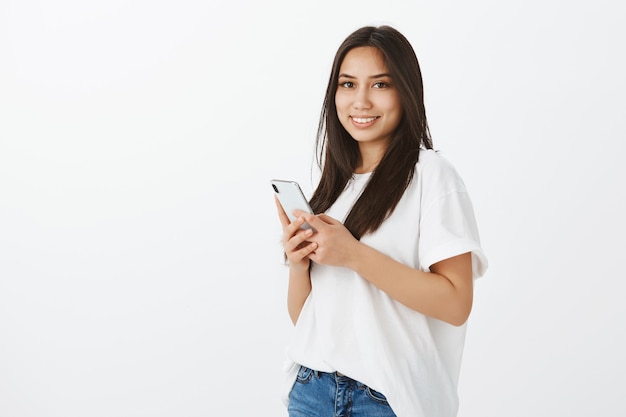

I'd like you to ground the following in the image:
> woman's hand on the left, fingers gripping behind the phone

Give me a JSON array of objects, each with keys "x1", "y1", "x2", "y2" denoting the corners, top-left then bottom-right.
[{"x1": 274, "y1": 196, "x2": 317, "y2": 270}]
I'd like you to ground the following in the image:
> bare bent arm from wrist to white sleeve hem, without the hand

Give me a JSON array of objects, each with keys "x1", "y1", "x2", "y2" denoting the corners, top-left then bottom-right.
[{"x1": 347, "y1": 242, "x2": 473, "y2": 326}]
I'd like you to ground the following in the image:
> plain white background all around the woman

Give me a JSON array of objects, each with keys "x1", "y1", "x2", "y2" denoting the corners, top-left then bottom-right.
[{"x1": 0, "y1": 0, "x2": 626, "y2": 417}]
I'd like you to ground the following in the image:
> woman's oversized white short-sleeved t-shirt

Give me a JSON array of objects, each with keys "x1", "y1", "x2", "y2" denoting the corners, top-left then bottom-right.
[{"x1": 283, "y1": 150, "x2": 487, "y2": 417}]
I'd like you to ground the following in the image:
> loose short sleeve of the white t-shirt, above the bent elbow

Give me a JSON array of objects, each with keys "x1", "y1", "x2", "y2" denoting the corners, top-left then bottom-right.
[{"x1": 418, "y1": 190, "x2": 487, "y2": 279}]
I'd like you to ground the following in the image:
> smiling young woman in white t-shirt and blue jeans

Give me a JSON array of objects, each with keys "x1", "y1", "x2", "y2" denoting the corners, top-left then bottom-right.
[{"x1": 277, "y1": 26, "x2": 487, "y2": 417}]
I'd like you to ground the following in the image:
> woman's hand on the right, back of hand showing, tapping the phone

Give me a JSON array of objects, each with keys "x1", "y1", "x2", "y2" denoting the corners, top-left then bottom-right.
[{"x1": 294, "y1": 210, "x2": 359, "y2": 266}]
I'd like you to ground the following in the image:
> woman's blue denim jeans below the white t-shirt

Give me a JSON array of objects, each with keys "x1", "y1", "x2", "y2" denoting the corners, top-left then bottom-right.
[{"x1": 288, "y1": 366, "x2": 395, "y2": 417}]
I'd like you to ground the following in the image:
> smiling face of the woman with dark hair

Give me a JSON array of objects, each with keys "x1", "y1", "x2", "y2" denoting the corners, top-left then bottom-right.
[{"x1": 335, "y1": 46, "x2": 402, "y2": 149}]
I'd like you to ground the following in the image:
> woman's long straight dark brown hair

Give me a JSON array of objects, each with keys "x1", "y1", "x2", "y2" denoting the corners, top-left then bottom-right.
[{"x1": 310, "y1": 26, "x2": 433, "y2": 239}]
